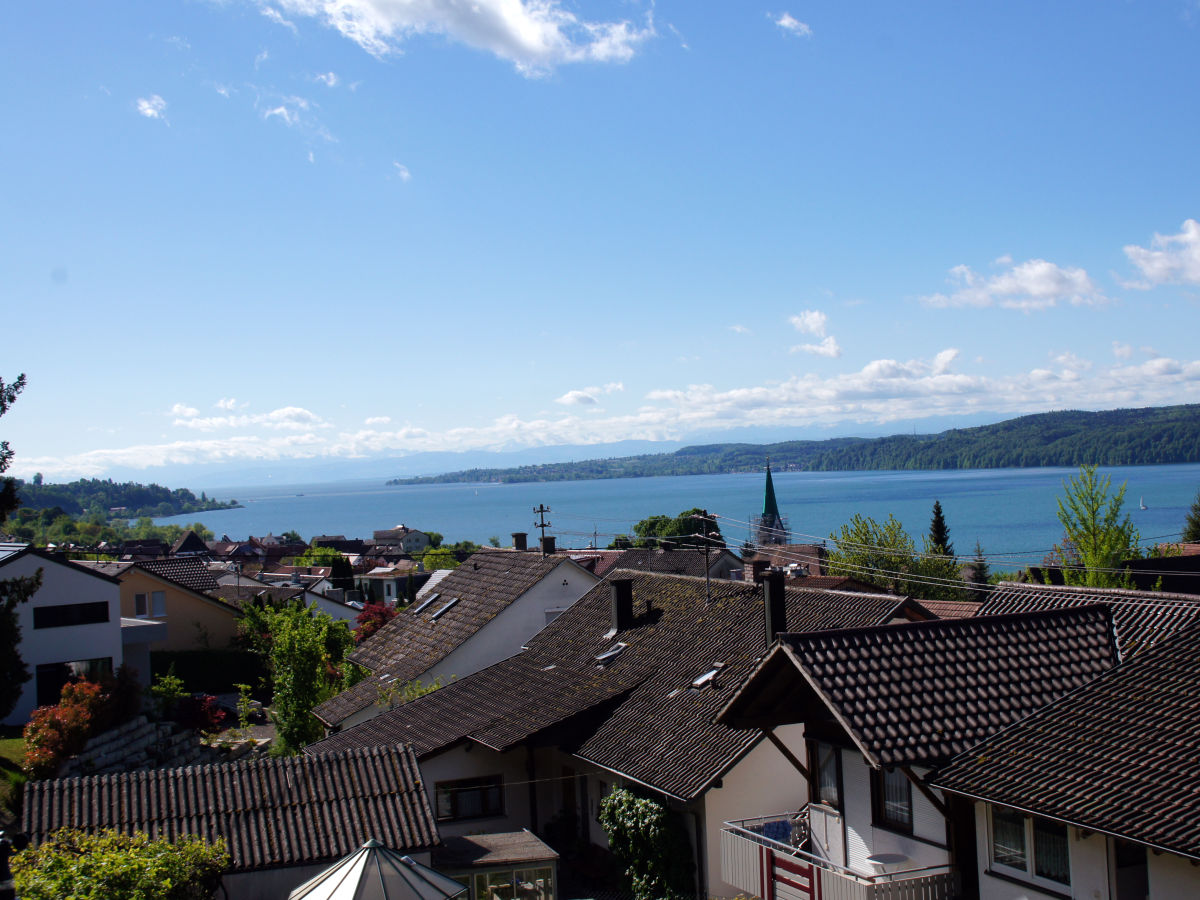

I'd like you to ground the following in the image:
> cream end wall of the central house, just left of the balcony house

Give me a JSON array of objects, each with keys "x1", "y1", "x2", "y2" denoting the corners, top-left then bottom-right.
[{"x1": 698, "y1": 725, "x2": 809, "y2": 898}]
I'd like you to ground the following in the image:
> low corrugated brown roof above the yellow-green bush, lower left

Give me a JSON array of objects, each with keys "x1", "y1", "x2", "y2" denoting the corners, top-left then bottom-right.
[{"x1": 25, "y1": 746, "x2": 438, "y2": 871}]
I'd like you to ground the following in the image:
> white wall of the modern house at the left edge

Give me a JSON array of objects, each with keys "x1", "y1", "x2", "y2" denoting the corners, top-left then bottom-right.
[{"x1": 0, "y1": 553, "x2": 124, "y2": 725}]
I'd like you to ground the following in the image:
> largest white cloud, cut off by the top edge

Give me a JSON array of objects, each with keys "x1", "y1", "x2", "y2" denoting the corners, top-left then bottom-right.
[{"x1": 264, "y1": 0, "x2": 655, "y2": 74}]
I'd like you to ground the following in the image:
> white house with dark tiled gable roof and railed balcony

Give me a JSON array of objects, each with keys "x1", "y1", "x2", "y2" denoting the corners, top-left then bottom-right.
[{"x1": 716, "y1": 606, "x2": 1116, "y2": 900}]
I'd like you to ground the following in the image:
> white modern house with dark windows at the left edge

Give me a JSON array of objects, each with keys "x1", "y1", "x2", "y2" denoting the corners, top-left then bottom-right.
[{"x1": 0, "y1": 544, "x2": 162, "y2": 725}]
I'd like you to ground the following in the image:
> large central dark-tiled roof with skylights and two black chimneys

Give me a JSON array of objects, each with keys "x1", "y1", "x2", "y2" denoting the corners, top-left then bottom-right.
[{"x1": 311, "y1": 570, "x2": 905, "y2": 799}]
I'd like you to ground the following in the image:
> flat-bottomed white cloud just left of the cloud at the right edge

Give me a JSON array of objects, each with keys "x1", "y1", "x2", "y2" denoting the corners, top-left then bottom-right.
[{"x1": 922, "y1": 259, "x2": 1108, "y2": 312}]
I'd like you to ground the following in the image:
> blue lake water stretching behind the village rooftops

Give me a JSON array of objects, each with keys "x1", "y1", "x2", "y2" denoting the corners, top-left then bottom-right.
[{"x1": 157, "y1": 464, "x2": 1200, "y2": 570}]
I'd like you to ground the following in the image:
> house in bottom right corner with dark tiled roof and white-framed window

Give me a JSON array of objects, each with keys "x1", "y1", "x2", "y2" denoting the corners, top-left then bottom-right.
[{"x1": 929, "y1": 624, "x2": 1200, "y2": 900}]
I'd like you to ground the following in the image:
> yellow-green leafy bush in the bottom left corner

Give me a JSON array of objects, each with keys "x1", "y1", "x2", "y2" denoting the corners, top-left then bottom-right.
[{"x1": 12, "y1": 828, "x2": 229, "y2": 900}]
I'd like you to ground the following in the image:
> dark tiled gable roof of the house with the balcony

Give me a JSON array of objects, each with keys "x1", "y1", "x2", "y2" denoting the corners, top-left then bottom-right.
[{"x1": 720, "y1": 606, "x2": 1116, "y2": 768}]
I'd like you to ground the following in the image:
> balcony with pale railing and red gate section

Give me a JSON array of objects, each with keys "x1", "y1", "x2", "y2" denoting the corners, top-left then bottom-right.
[{"x1": 721, "y1": 806, "x2": 959, "y2": 900}]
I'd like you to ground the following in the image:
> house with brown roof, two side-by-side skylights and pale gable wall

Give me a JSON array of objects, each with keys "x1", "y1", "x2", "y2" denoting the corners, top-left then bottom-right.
[{"x1": 313, "y1": 550, "x2": 596, "y2": 728}]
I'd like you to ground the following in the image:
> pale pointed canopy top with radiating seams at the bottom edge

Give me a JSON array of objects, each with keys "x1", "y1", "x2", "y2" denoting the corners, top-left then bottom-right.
[{"x1": 288, "y1": 839, "x2": 468, "y2": 900}]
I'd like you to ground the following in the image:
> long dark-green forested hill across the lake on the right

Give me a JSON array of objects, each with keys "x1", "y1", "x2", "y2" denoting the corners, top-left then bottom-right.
[{"x1": 388, "y1": 404, "x2": 1200, "y2": 485}]
